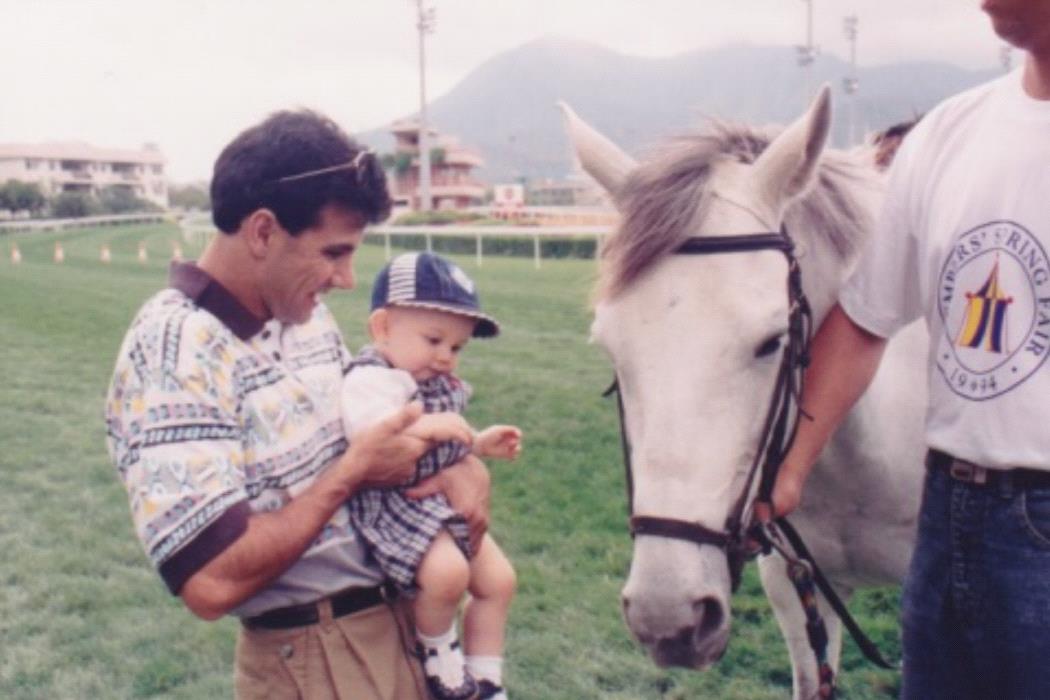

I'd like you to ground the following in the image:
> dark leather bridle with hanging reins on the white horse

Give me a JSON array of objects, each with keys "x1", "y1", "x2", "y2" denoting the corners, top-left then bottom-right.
[{"x1": 603, "y1": 227, "x2": 895, "y2": 698}]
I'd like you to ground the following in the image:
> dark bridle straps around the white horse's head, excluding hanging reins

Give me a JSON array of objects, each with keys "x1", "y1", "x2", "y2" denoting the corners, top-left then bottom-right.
[{"x1": 605, "y1": 228, "x2": 812, "y2": 590}]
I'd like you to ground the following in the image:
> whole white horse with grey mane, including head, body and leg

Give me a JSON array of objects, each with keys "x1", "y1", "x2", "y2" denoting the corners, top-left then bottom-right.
[{"x1": 562, "y1": 87, "x2": 928, "y2": 700}]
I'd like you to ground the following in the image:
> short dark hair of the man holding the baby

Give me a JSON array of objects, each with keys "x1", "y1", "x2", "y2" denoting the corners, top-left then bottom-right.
[{"x1": 211, "y1": 110, "x2": 391, "y2": 235}]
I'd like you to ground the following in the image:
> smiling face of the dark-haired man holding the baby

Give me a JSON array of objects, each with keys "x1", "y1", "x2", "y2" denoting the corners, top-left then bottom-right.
[{"x1": 259, "y1": 206, "x2": 364, "y2": 323}]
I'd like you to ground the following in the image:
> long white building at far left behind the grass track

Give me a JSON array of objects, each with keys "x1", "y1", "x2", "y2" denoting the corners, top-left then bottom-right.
[{"x1": 0, "y1": 143, "x2": 168, "y2": 209}]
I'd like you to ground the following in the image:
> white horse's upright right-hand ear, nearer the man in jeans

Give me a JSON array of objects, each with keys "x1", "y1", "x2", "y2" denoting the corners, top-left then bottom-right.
[{"x1": 755, "y1": 83, "x2": 832, "y2": 208}]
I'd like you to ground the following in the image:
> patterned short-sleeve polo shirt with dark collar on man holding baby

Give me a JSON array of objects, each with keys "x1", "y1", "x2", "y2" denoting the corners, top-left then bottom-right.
[{"x1": 106, "y1": 264, "x2": 381, "y2": 615}]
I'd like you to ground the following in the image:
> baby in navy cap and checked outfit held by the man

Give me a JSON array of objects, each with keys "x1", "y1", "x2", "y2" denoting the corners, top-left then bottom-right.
[{"x1": 342, "y1": 253, "x2": 522, "y2": 700}]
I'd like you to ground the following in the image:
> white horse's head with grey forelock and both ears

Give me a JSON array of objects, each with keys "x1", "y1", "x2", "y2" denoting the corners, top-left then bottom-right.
[{"x1": 562, "y1": 87, "x2": 872, "y2": 669}]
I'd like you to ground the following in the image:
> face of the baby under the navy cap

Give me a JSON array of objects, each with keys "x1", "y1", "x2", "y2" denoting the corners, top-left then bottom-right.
[{"x1": 373, "y1": 306, "x2": 477, "y2": 381}]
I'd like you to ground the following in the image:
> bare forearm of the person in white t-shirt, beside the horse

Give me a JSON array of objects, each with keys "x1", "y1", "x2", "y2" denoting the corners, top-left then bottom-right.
[{"x1": 757, "y1": 304, "x2": 886, "y2": 517}]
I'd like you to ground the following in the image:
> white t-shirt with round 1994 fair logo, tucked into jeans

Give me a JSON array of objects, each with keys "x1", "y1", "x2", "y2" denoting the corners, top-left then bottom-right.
[{"x1": 840, "y1": 70, "x2": 1050, "y2": 470}]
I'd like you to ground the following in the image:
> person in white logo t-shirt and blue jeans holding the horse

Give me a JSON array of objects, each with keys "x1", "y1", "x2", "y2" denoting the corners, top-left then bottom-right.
[{"x1": 773, "y1": 0, "x2": 1050, "y2": 700}]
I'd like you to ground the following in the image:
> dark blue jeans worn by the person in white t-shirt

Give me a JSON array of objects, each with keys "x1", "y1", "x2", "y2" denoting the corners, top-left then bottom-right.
[{"x1": 901, "y1": 461, "x2": 1050, "y2": 700}]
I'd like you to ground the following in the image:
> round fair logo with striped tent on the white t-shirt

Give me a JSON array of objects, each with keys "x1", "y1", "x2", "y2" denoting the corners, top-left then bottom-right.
[{"x1": 937, "y1": 221, "x2": 1050, "y2": 401}]
